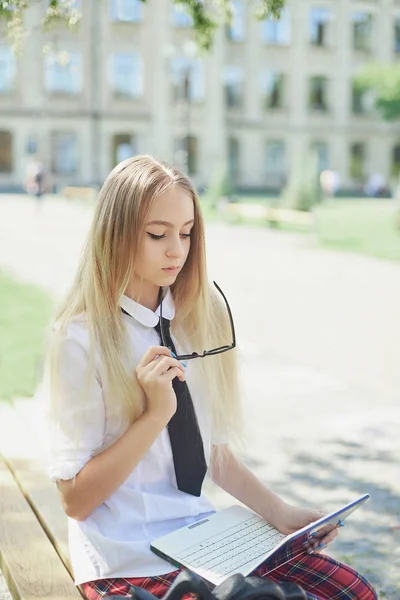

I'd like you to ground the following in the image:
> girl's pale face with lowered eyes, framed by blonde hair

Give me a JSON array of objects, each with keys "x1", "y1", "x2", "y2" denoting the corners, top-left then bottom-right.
[{"x1": 130, "y1": 187, "x2": 194, "y2": 305}]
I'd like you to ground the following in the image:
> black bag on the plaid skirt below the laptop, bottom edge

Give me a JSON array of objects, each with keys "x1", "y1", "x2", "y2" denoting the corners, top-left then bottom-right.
[{"x1": 109, "y1": 570, "x2": 307, "y2": 600}]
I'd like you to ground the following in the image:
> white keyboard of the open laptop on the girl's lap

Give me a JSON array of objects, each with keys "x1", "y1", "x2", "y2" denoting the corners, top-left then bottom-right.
[{"x1": 180, "y1": 515, "x2": 286, "y2": 575}]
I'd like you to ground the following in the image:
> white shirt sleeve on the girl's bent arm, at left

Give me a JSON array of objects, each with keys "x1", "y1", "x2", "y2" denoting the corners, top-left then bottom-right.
[{"x1": 47, "y1": 337, "x2": 105, "y2": 481}]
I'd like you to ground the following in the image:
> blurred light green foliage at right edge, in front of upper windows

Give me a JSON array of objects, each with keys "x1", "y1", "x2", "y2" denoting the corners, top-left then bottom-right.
[{"x1": 355, "y1": 63, "x2": 400, "y2": 121}]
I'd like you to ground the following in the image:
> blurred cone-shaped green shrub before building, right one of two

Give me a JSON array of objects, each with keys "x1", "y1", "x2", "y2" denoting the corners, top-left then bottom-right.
[{"x1": 281, "y1": 150, "x2": 322, "y2": 211}]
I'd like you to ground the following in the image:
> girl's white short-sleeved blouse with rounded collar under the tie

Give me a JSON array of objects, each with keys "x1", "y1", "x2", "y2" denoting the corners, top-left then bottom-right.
[{"x1": 45, "y1": 290, "x2": 219, "y2": 585}]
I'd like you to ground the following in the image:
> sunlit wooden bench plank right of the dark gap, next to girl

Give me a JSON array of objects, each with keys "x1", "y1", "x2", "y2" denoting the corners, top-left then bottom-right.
[{"x1": 0, "y1": 400, "x2": 72, "y2": 575}]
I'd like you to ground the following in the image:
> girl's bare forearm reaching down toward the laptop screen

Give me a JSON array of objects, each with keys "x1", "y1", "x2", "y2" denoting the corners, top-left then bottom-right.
[{"x1": 210, "y1": 446, "x2": 286, "y2": 526}]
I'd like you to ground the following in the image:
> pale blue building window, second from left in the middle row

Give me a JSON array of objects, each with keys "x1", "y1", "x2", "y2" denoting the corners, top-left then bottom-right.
[{"x1": 45, "y1": 52, "x2": 82, "y2": 95}]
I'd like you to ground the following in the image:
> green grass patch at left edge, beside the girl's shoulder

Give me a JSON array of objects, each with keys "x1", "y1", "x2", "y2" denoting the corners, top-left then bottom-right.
[{"x1": 0, "y1": 271, "x2": 53, "y2": 400}]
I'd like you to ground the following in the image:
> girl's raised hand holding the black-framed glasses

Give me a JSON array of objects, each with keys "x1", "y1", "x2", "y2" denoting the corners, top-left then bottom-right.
[{"x1": 136, "y1": 346, "x2": 185, "y2": 424}]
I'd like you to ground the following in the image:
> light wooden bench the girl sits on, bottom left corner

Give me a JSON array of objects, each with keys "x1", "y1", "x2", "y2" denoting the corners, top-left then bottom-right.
[{"x1": 0, "y1": 401, "x2": 82, "y2": 600}]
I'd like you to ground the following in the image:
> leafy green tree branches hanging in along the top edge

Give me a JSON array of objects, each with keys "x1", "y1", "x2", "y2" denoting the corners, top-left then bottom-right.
[{"x1": 0, "y1": 0, "x2": 286, "y2": 50}]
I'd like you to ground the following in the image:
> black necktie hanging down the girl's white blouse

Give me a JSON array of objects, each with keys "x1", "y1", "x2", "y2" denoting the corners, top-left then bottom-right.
[{"x1": 155, "y1": 317, "x2": 207, "y2": 496}]
